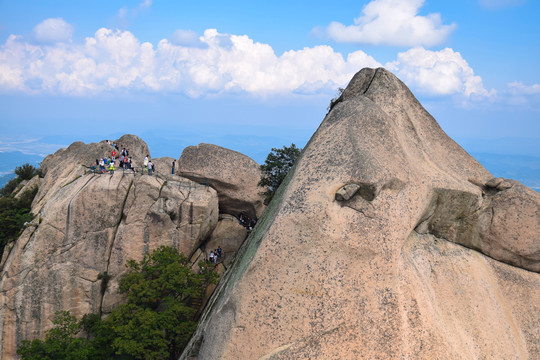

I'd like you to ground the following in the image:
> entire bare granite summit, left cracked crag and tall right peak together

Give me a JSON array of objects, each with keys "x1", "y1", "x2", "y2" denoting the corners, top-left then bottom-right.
[{"x1": 0, "y1": 69, "x2": 540, "y2": 360}]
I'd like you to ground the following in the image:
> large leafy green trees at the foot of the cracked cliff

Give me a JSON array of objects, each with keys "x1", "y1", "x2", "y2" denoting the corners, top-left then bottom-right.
[{"x1": 17, "y1": 247, "x2": 217, "y2": 360}]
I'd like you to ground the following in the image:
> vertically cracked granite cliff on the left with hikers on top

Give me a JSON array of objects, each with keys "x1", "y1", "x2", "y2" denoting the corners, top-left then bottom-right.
[{"x1": 0, "y1": 136, "x2": 219, "y2": 359}]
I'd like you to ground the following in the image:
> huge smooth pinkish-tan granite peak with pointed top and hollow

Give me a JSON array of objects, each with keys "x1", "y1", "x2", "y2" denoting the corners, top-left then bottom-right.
[{"x1": 181, "y1": 69, "x2": 540, "y2": 360}]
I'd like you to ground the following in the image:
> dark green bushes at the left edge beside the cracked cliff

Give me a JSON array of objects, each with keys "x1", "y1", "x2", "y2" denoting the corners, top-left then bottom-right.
[{"x1": 0, "y1": 164, "x2": 39, "y2": 258}]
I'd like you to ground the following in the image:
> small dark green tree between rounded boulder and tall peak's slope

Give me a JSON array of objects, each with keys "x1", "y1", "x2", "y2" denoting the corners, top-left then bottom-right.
[{"x1": 259, "y1": 144, "x2": 302, "y2": 203}]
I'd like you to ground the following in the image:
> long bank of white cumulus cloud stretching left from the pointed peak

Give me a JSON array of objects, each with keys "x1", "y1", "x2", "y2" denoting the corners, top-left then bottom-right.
[{"x1": 0, "y1": 28, "x2": 380, "y2": 96}]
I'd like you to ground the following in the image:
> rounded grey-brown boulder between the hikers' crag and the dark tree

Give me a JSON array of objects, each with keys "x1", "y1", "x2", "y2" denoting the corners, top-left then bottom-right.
[{"x1": 177, "y1": 144, "x2": 264, "y2": 219}]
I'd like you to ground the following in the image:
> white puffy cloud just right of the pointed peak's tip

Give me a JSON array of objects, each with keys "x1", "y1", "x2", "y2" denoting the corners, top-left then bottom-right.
[{"x1": 386, "y1": 47, "x2": 495, "y2": 98}]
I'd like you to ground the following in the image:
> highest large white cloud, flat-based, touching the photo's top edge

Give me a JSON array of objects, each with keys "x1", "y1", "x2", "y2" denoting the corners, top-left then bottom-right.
[{"x1": 320, "y1": 0, "x2": 456, "y2": 46}]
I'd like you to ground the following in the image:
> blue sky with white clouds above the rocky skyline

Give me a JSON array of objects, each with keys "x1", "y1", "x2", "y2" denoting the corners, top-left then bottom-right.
[{"x1": 0, "y1": 0, "x2": 540, "y2": 166}]
